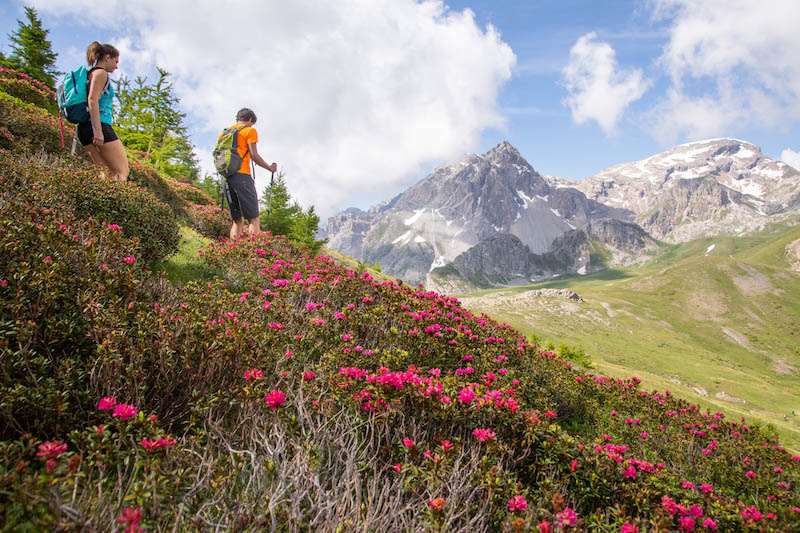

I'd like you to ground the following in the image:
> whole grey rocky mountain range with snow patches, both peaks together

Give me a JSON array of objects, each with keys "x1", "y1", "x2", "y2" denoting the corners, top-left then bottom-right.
[{"x1": 326, "y1": 135, "x2": 800, "y2": 292}]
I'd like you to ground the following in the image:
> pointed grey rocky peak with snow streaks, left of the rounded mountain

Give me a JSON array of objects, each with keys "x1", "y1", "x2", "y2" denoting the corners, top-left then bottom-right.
[{"x1": 326, "y1": 142, "x2": 633, "y2": 283}]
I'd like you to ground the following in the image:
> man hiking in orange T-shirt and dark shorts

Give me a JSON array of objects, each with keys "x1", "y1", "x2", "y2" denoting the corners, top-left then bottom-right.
[{"x1": 220, "y1": 107, "x2": 278, "y2": 239}]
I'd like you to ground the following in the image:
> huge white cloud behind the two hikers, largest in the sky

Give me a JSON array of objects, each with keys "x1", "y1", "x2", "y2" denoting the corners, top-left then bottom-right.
[{"x1": 32, "y1": 0, "x2": 516, "y2": 216}]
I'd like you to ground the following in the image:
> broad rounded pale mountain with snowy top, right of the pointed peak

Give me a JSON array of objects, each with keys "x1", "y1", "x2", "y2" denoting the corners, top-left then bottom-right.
[{"x1": 564, "y1": 139, "x2": 800, "y2": 242}]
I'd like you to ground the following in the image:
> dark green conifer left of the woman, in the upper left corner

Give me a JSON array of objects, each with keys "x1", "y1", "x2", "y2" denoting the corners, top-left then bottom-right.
[{"x1": 4, "y1": 7, "x2": 60, "y2": 89}]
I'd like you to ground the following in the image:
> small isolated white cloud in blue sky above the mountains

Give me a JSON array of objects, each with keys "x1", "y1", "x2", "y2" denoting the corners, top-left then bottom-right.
[{"x1": 562, "y1": 32, "x2": 650, "y2": 134}]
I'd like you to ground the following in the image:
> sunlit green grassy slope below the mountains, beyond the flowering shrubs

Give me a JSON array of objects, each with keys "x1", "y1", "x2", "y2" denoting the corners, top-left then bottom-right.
[{"x1": 462, "y1": 222, "x2": 800, "y2": 450}]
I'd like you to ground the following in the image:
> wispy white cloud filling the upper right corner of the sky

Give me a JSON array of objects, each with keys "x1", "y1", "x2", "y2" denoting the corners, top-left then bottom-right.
[{"x1": 650, "y1": 0, "x2": 800, "y2": 142}]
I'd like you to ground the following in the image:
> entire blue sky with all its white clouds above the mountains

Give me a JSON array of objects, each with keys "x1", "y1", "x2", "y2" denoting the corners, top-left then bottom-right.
[{"x1": 0, "y1": 0, "x2": 800, "y2": 217}]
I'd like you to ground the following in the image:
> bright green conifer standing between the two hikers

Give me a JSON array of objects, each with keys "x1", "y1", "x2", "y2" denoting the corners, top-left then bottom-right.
[{"x1": 114, "y1": 68, "x2": 200, "y2": 183}]
